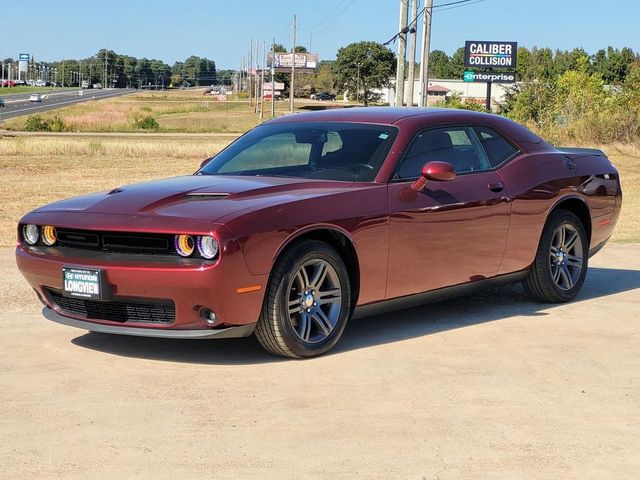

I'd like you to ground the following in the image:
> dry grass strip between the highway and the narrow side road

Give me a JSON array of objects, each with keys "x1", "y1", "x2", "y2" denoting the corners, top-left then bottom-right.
[{"x1": 2, "y1": 89, "x2": 317, "y2": 133}]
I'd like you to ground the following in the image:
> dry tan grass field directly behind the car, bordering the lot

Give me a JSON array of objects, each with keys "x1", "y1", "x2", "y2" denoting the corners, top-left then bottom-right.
[{"x1": 0, "y1": 135, "x2": 640, "y2": 246}]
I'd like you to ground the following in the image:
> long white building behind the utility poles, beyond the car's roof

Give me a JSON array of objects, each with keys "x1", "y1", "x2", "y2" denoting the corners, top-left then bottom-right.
[{"x1": 374, "y1": 78, "x2": 512, "y2": 106}]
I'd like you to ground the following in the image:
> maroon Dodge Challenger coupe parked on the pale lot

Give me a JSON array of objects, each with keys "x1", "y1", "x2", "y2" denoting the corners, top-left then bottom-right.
[{"x1": 16, "y1": 108, "x2": 622, "y2": 358}]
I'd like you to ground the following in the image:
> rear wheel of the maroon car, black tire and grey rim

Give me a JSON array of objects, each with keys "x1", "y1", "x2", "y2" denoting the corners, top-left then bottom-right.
[{"x1": 523, "y1": 209, "x2": 589, "y2": 303}]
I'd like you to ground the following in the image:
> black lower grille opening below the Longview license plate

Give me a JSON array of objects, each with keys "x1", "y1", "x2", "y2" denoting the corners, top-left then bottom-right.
[{"x1": 47, "y1": 290, "x2": 176, "y2": 324}]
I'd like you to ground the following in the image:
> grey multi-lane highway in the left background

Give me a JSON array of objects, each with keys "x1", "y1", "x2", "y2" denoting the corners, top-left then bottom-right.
[{"x1": 0, "y1": 88, "x2": 136, "y2": 120}]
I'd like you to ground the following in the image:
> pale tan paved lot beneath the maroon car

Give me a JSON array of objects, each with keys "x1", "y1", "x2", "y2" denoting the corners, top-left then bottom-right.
[{"x1": 0, "y1": 244, "x2": 640, "y2": 480}]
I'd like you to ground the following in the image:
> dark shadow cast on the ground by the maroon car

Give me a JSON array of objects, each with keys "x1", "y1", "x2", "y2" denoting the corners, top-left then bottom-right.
[{"x1": 72, "y1": 268, "x2": 640, "y2": 365}]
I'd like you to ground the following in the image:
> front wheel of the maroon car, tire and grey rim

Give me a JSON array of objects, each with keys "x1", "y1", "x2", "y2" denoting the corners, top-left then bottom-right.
[{"x1": 255, "y1": 240, "x2": 351, "y2": 358}]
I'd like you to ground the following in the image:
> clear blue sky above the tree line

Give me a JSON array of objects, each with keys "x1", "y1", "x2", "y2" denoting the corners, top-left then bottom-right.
[{"x1": 0, "y1": 0, "x2": 640, "y2": 68}]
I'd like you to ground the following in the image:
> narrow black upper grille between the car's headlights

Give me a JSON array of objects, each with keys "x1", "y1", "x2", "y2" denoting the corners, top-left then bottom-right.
[{"x1": 57, "y1": 228, "x2": 176, "y2": 255}]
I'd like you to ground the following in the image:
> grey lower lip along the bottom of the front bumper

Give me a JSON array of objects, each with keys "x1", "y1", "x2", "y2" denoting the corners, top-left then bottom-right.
[{"x1": 42, "y1": 307, "x2": 255, "y2": 339}]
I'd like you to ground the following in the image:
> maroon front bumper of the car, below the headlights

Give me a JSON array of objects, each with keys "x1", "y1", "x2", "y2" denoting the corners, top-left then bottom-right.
[{"x1": 16, "y1": 245, "x2": 268, "y2": 338}]
